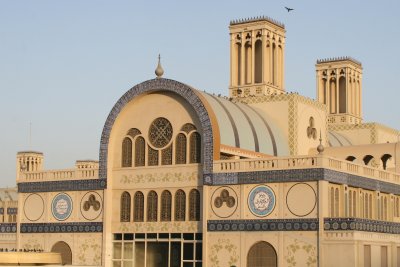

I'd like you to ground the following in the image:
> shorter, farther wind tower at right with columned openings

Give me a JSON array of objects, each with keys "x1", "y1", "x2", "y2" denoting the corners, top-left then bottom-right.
[{"x1": 315, "y1": 57, "x2": 362, "y2": 124}]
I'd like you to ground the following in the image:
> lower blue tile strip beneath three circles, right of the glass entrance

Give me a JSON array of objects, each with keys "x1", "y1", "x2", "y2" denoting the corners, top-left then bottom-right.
[{"x1": 207, "y1": 219, "x2": 318, "y2": 232}]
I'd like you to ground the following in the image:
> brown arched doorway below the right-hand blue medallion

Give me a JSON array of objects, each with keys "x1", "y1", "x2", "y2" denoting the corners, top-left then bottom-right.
[{"x1": 247, "y1": 241, "x2": 278, "y2": 267}]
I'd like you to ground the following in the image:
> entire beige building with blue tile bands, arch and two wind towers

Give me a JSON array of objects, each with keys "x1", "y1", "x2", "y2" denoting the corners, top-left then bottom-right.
[{"x1": 4, "y1": 17, "x2": 400, "y2": 267}]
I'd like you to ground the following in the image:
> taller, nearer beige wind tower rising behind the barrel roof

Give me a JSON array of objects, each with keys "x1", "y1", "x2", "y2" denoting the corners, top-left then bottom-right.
[{"x1": 229, "y1": 16, "x2": 286, "y2": 98}]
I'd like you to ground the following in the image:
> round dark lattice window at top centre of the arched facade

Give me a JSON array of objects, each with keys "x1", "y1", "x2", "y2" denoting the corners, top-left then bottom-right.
[{"x1": 149, "y1": 117, "x2": 172, "y2": 148}]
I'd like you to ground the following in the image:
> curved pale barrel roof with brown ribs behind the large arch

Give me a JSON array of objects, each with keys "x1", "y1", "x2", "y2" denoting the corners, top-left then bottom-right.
[{"x1": 200, "y1": 92, "x2": 289, "y2": 156}]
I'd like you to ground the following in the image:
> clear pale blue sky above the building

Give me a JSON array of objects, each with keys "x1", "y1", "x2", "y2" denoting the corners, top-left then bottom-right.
[{"x1": 0, "y1": 0, "x2": 400, "y2": 187}]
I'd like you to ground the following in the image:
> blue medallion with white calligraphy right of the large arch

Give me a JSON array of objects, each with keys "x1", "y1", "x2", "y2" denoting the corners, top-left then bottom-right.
[{"x1": 248, "y1": 185, "x2": 275, "y2": 217}]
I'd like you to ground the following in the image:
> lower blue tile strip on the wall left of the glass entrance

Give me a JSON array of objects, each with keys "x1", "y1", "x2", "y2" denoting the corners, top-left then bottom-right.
[{"x1": 20, "y1": 222, "x2": 103, "y2": 233}]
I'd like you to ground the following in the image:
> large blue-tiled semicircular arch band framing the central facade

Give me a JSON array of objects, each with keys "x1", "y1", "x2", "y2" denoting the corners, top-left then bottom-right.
[{"x1": 99, "y1": 78, "x2": 220, "y2": 183}]
